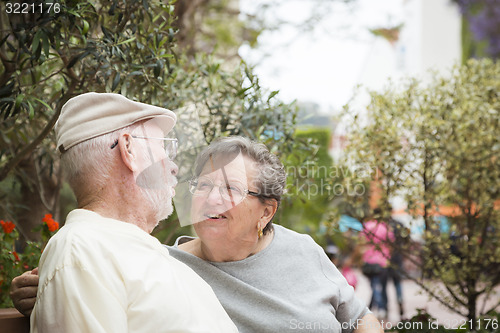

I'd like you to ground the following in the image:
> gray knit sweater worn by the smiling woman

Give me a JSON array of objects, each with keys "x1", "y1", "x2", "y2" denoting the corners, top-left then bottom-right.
[{"x1": 168, "y1": 225, "x2": 368, "y2": 333}]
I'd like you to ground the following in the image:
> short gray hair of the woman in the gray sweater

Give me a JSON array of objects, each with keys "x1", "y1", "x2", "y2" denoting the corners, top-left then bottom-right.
[{"x1": 195, "y1": 136, "x2": 286, "y2": 233}]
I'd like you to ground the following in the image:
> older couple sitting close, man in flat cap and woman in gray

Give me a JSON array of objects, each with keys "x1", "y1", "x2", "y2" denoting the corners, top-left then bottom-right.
[{"x1": 11, "y1": 93, "x2": 383, "y2": 333}]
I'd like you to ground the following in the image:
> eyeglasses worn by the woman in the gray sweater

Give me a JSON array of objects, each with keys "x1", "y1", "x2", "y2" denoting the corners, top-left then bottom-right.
[{"x1": 189, "y1": 177, "x2": 260, "y2": 205}]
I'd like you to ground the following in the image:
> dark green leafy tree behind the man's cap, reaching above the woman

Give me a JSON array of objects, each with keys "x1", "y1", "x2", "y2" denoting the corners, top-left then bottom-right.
[{"x1": 0, "y1": 0, "x2": 307, "y2": 244}]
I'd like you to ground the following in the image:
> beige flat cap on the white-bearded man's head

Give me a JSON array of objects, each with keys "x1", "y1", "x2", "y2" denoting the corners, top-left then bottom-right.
[{"x1": 54, "y1": 92, "x2": 177, "y2": 153}]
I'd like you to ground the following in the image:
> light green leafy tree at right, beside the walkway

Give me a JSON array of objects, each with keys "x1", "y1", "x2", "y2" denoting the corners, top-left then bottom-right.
[{"x1": 340, "y1": 59, "x2": 500, "y2": 322}]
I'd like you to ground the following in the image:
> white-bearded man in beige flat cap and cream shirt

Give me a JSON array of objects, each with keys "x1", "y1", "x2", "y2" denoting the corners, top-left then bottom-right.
[{"x1": 25, "y1": 93, "x2": 237, "y2": 333}]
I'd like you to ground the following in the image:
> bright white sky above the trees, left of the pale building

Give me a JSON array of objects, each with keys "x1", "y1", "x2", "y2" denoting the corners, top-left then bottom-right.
[{"x1": 239, "y1": 0, "x2": 404, "y2": 113}]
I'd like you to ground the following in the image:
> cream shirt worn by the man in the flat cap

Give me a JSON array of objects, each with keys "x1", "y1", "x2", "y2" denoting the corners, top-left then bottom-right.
[{"x1": 31, "y1": 209, "x2": 237, "y2": 333}]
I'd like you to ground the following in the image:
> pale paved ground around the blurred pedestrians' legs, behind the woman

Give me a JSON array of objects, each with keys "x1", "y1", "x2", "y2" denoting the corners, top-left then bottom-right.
[{"x1": 356, "y1": 271, "x2": 464, "y2": 327}]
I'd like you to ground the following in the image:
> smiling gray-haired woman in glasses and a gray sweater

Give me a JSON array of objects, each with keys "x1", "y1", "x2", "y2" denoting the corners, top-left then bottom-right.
[{"x1": 13, "y1": 137, "x2": 383, "y2": 333}]
